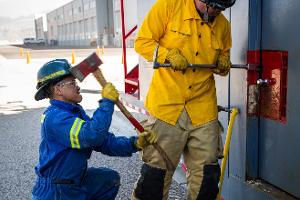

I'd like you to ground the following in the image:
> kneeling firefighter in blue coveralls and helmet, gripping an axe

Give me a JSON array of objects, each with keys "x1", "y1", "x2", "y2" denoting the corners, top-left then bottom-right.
[{"x1": 32, "y1": 59, "x2": 157, "y2": 200}]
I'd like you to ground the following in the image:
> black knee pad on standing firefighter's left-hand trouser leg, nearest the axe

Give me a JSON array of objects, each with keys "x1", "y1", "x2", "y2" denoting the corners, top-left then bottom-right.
[{"x1": 134, "y1": 164, "x2": 166, "y2": 200}]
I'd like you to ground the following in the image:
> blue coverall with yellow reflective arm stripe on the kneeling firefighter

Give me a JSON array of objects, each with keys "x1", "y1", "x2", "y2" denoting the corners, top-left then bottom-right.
[{"x1": 32, "y1": 98, "x2": 137, "y2": 200}]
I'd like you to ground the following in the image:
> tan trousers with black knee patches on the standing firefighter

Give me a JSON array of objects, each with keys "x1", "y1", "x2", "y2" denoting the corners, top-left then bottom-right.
[{"x1": 132, "y1": 109, "x2": 222, "y2": 200}]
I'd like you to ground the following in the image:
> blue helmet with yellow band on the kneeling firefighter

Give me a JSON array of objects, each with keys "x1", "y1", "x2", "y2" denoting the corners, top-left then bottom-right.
[{"x1": 34, "y1": 59, "x2": 71, "y2": 101}]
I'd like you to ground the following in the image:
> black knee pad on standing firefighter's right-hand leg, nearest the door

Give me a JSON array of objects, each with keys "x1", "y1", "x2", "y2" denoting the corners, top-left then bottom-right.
[{"x1": 197, "y1": 164, "x2": 221, "y2": 200}]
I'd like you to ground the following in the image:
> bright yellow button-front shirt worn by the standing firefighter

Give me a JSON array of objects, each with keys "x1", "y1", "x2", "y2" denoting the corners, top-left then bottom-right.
[{"x1": 135, "y1": 0, "x2": 231, "y2": 126}]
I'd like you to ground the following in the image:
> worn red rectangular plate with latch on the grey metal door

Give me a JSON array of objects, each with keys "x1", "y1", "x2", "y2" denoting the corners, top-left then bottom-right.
[{"x1": 247, "y1": 50, "x2": 288, "y2": 123}]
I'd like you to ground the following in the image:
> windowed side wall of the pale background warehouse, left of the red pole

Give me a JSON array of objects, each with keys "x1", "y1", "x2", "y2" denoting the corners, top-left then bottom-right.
[{"x1": 47, "y1": 0, "x2": 114, "y2": 46}]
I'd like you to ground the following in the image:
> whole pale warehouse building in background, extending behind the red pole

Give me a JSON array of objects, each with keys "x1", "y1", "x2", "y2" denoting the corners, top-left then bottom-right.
[{"x1": 43, "y1": 0, "x2": 137, "y2": 47}]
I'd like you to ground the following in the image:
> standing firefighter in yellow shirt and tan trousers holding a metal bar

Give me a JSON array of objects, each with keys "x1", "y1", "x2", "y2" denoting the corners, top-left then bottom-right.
[{"x1": 133, "y1": 0, "x2": 235, "y2": 200}]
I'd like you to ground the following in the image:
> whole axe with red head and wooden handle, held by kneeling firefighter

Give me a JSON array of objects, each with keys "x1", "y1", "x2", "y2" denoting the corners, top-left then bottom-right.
[{"x1": 70, "y1": 53, "x2": 175, "y2": 171}]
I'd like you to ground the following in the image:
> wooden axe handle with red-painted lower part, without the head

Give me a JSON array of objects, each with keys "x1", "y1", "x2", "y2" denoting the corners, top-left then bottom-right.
[{"x1": 93, "y1": 68, "x2": 175, "y2": 171}]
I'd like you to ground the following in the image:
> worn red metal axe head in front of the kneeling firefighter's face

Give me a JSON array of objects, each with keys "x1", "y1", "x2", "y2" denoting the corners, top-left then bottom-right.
[{"x1": 70, "y1": 53, "x2": 103, "y2": 82}]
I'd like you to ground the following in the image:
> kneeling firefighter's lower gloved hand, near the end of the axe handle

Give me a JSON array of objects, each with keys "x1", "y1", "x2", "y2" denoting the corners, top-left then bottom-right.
[{"x1": 135, "y1": 129, "x2": 157, "y2": 150}]
